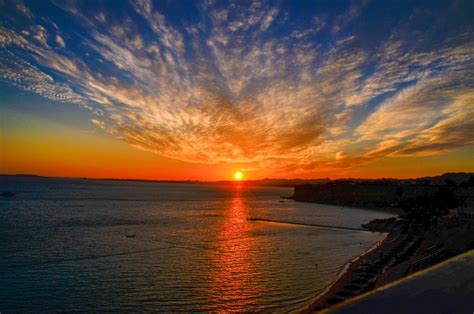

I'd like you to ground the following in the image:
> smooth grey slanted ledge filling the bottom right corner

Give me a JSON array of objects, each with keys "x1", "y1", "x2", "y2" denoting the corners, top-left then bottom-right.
[{"x1": 326, "y1": 250, "x2": 474, "y2": 314}]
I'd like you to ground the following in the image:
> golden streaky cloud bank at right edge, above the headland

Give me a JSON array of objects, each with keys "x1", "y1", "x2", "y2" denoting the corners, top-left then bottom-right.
[{"x1": 356, "y1": 68, "x2": 474, "y2": 156}]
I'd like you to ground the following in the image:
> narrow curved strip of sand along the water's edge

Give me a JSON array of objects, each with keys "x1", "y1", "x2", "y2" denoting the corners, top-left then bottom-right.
[{"x1": 300, "y1": 232, "x2": 390, "y2": 313}]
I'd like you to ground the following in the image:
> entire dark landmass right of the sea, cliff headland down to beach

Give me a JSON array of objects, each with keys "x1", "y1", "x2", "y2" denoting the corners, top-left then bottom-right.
[{"x1": 293, "y1": 174, "x2": 474, "y2": 312}]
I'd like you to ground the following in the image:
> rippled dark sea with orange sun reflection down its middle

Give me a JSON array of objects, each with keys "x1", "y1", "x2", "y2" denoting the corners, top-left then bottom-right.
[{"x1": 0, "y1": 177, "x2": 390, "y2": 311}]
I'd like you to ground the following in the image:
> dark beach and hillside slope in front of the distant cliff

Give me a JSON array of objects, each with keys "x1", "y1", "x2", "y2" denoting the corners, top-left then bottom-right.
[{"x1": 302, "y1": 213, "x2": 474, "y2": 313}]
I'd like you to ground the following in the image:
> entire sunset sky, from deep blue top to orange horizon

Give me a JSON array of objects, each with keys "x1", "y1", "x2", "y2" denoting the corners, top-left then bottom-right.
[{"x1": 0, "y1": 0, "x2": 474, "y2": 180}]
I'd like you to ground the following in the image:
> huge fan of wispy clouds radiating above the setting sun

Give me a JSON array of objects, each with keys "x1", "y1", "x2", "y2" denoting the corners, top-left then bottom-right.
[{"x1": 0, "y1": 0, "x2": 474, "y2": 171}]
